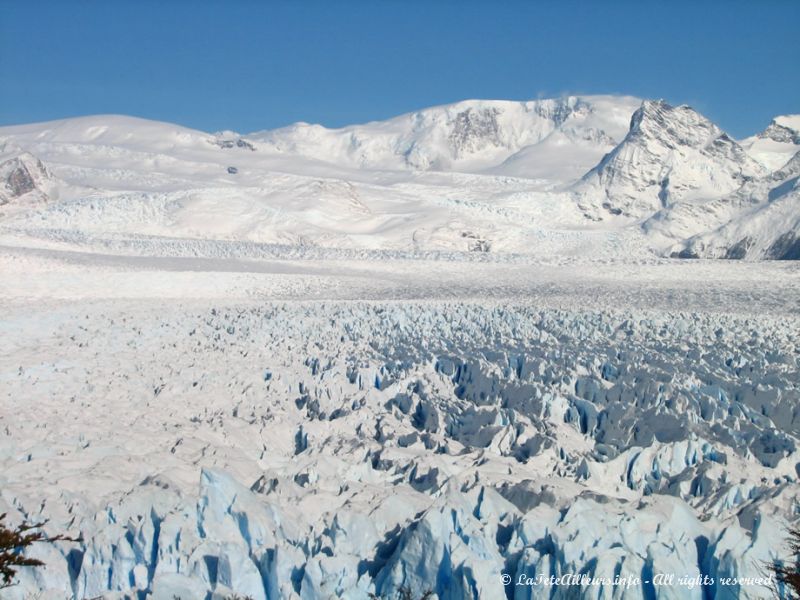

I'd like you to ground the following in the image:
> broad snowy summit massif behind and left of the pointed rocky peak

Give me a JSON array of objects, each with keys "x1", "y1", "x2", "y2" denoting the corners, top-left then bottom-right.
[{"x1": 249, "y1": 96, "x2": 641, "y2": 181}]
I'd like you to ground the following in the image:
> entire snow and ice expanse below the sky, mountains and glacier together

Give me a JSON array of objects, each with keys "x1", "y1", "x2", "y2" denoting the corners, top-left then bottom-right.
[{"x1": 0, "y1": 97, "x2": 800, "y2": 600}]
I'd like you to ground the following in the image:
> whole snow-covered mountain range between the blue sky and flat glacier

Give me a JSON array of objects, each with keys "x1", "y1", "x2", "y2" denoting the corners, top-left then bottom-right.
[{"x1": 0, "y1": 96, "x2": 800, "y2": 259}]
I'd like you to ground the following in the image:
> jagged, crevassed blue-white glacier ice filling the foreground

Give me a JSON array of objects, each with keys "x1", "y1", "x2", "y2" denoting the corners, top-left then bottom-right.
[{"x1": 1, "y1": 301, "x2": 800, "y2": 598}]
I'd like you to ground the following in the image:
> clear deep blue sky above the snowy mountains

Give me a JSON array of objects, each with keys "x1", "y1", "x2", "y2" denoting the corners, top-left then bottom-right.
[{"x1": 0, "y1": 0, "x2": 800, "y2": 137}]
